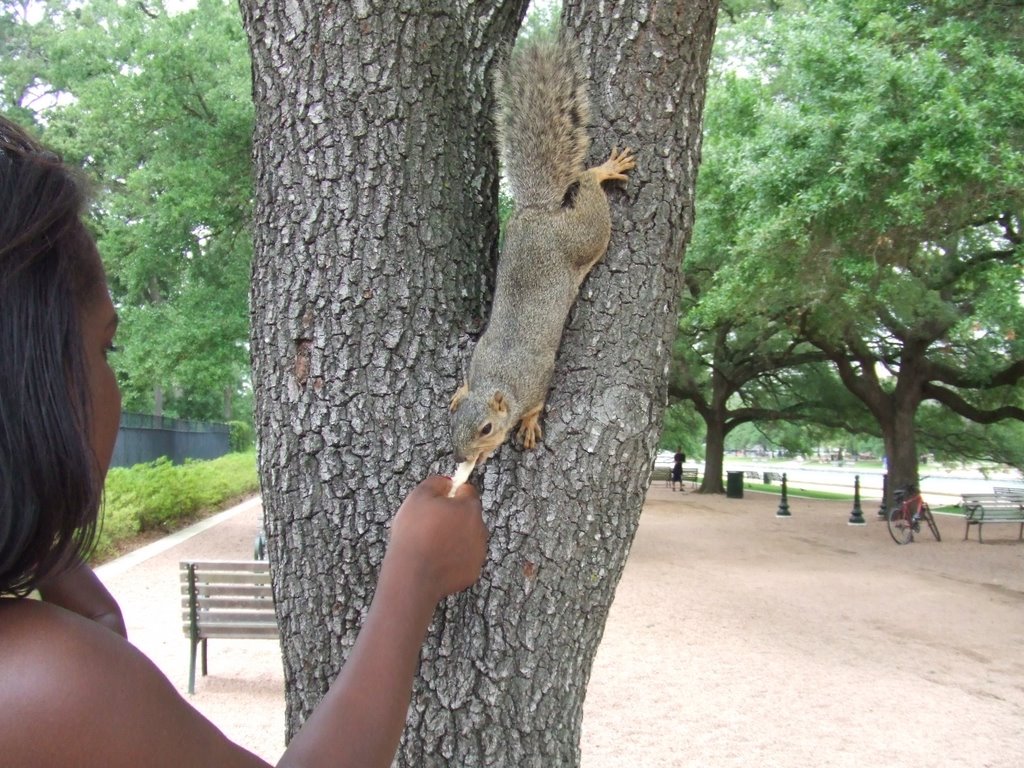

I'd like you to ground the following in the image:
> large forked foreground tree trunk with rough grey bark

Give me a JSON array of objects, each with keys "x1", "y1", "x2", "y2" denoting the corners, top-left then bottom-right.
[{"x1": 243, "y1": 0, "x2": 717, "y2": 766}]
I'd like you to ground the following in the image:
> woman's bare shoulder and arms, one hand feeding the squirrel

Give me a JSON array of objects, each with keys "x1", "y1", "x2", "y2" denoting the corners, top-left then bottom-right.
[{"x1": 0, "y1": 477, "x2": 487, "y2": 768}]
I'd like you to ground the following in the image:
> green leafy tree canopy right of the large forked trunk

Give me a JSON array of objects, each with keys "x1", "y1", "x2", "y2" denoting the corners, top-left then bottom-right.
[{"x1": 681, "y1": 0, "x2": 1024, "y2": 473}]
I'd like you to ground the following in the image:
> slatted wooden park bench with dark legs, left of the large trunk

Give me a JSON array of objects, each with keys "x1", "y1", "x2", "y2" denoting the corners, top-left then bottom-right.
[{"x1": 181, "y1": 560, "x2": 278, "y2": 693}]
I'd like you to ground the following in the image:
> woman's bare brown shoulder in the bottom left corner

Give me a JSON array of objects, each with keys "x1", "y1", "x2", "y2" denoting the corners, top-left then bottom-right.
[{"x1": 0, "y1": 599, "x2": 266, "y2": 768}]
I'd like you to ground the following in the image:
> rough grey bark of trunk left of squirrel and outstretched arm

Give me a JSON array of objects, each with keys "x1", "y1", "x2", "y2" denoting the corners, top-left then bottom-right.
[{"x1": 243, "y1": 0, "x2": 519, "y2": 732}]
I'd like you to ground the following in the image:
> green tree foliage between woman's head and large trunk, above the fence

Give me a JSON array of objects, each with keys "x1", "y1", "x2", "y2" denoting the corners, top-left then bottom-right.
[{"x1": 0, "y1": 0, "x2": 253, "y2": 420}]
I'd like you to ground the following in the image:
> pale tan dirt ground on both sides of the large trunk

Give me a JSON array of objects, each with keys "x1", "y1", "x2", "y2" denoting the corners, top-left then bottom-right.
[{"x1": 99, "y1": 483, "x2": 1024, "y2": 768}]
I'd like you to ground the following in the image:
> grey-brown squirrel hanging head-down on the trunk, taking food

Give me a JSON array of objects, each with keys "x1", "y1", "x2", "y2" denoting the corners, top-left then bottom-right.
[{"x1": 450, "y1": 33, "x2": 636, "y2": 467}]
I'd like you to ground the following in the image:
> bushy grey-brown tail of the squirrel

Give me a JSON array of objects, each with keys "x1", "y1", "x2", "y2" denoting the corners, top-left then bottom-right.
[{"x1": 497, "y1": 34, "x2": 590, "y2": 209}]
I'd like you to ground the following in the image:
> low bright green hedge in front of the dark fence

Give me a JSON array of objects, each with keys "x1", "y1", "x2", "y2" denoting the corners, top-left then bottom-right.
[{"x1": 91, "y1": 452, "x2": 259, "y2": 560}]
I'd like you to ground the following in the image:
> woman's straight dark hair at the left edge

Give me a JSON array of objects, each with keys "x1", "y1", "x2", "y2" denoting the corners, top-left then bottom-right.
[{"x1": 0, "y1": 116, "x2": 102, "y2": 595}]
